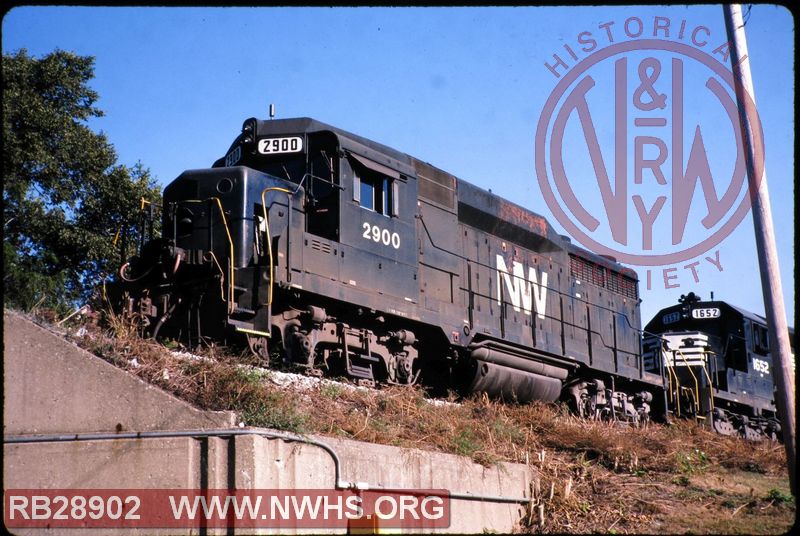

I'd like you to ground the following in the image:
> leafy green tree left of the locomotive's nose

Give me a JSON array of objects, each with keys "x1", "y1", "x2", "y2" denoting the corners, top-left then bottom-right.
[{"x1": 2, "y1": 49, "x2": 159, "y2": 309}]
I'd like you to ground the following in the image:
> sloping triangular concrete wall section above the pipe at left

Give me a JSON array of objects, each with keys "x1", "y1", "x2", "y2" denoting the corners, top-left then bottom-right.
[{"x1": 3, "y1": 311, "x2": 235, "y2": 434}]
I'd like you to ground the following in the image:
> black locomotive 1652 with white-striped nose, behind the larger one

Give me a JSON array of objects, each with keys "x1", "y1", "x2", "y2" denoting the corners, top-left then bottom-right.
[{"x1": 643, "y1": 293, "x2": 794, "y2": 439}]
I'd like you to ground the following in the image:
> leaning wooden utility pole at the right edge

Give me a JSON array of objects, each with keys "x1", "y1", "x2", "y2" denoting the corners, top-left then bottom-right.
[{"x1": 722, "y1": 4, "x2": 797, "y2": 496}]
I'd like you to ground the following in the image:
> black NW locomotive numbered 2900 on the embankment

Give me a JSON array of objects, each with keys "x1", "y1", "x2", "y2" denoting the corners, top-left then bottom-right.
[{"x1": 115, "y1": 118, "x2": 666, "y2": 422}]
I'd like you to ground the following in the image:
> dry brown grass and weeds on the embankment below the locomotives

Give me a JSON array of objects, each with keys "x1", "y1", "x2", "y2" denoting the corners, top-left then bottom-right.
[{"x1": 25, "y1": 308, "x2": 795, "y2": 534}]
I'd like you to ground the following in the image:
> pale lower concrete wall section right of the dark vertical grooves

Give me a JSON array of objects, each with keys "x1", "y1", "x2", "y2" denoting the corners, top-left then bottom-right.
[{"x1": 236, "y1": 436, "x2": 532, "y2": 534}]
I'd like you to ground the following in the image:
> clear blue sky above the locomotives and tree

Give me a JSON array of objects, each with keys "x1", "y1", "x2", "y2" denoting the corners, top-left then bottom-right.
[{"x1": 2, "y1": 5, "x2": 795, "y2": 324}]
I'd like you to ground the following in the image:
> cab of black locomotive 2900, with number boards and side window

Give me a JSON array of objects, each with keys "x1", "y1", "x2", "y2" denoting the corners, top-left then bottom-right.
[{"x1": 214, "y1": 118, "x2": 417, "y2": 303}]
